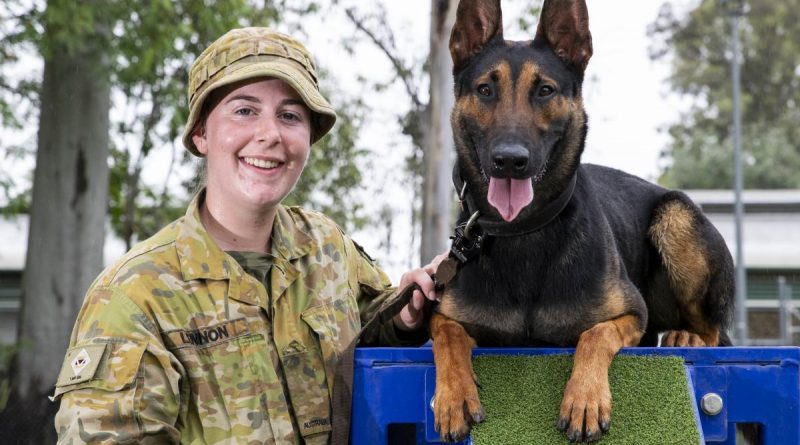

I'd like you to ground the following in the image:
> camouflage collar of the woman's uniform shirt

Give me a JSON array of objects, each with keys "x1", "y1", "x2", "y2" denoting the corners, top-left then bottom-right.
[{"x1": 175, "y1": 189, "x2": 312, "y2": 281}]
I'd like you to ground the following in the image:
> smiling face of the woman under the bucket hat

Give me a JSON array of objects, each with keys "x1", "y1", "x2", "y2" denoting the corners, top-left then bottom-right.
[{"x1": 192, "y1": 79, "x2": 311, "y2": 212}]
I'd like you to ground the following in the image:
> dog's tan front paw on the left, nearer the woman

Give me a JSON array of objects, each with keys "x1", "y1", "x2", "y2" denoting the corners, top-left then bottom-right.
[{"x1": 431, "y1": 381, "x2": 485, "y2": 442}]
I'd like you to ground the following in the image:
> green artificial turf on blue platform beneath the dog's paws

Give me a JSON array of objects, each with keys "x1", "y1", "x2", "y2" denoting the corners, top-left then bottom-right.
[{"x1": 472, "y1": 355, "x2": 700, "y2": 445}]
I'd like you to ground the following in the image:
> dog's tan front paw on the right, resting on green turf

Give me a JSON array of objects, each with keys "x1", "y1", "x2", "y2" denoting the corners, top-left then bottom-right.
[{"x1": 556, "y1": 378, "x2": 611, "y2": 442}]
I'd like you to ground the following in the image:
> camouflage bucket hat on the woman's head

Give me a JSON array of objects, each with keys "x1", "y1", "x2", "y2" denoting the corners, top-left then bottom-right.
[{"x1": 183, "y1": 28, "x2": 336, "y2": 156}]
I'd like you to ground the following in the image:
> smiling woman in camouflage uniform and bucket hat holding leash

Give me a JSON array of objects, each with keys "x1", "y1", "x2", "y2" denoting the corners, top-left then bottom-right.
[{"x1": 54, "y1": 28, "x2": 435, "y2": 444}]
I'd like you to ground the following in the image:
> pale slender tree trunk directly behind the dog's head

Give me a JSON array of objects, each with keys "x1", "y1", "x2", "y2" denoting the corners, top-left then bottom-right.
[{"x1": 420, "y1": 0, "x2": 458, "y2": 264}]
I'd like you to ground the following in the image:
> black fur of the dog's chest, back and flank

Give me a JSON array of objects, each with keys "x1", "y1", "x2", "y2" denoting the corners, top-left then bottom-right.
[{"x1": 448, "y1": 168, "x2": 733, "y2": 346}]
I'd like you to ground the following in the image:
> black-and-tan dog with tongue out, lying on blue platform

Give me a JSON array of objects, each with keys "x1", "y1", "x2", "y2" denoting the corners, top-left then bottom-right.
[{"x1": 430, "y1": 0, "x2": 733, "y2": 441}]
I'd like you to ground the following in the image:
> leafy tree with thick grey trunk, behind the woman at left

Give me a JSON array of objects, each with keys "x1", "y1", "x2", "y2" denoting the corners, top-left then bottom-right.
[{"x1": 0, "y1": 0, "x2": 368, "y2": 443}]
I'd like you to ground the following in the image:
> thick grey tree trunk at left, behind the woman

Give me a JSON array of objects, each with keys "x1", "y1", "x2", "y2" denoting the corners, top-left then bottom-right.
[{"x1": 0, "y1": 5, "x2": 110, "y2": 443}]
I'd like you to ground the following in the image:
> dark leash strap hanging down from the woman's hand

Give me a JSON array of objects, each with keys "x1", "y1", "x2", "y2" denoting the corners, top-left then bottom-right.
[{"x1": 330, "y1": 284, "x2": 420, "y2": 445}]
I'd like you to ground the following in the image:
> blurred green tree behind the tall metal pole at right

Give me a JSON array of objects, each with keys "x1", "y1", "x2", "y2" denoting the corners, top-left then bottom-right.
[{"x1": 649, "y1": 0, "x2": 800, "y2": 188}]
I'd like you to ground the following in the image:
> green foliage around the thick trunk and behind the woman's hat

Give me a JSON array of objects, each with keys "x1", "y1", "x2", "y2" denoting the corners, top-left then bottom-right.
[{"x1": 0, "y1": 0, "x2": 364, "y2": 241}]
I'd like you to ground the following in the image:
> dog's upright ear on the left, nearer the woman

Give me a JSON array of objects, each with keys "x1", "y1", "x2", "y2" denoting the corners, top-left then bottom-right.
[{"x1": 450, "y1": 0, "x2": 503, "y2": 72}]
